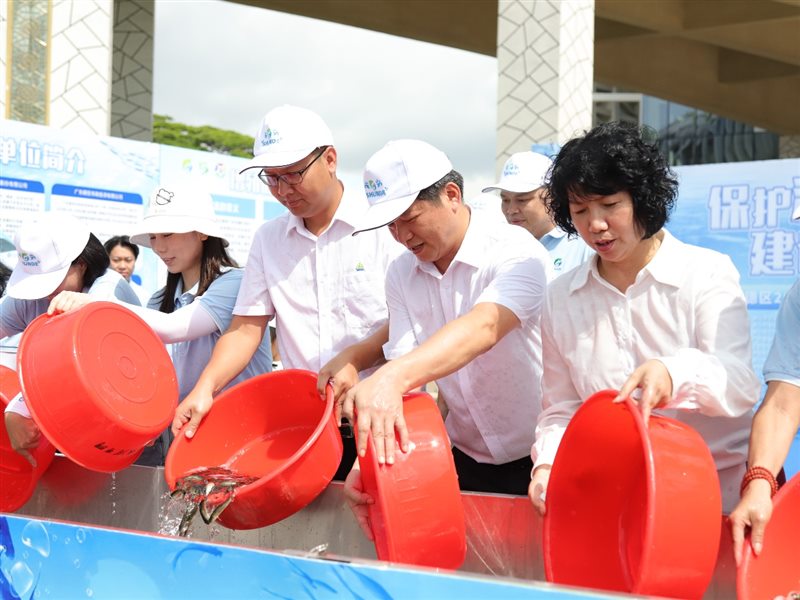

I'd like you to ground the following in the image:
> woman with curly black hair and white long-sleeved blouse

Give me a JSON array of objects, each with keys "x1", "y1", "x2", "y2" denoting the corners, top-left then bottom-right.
[{"x1": 529, "y1": 123, "x2": 759, "y2": 514}]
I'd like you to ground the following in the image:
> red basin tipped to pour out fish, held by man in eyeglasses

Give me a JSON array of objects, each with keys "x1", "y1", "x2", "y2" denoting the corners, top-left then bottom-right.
[{"x1": 164, "y1": 369, "x2": 342, "y2": 529}]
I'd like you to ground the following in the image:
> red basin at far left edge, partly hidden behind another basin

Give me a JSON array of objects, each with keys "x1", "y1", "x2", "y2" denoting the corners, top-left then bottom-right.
[{"x1": 0, "y1": 366, "x2": 55, "y2": 512}]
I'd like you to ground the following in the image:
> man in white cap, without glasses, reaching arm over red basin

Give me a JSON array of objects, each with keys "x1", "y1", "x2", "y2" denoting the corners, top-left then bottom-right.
[{"x1": 324, "y1": 140, "x2": 549, "y2": 496}]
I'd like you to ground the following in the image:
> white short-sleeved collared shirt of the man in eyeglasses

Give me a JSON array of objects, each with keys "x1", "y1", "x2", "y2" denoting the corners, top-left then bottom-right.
[{"x1": 233, "y1": 191, "x2": 403, "y2": 372}]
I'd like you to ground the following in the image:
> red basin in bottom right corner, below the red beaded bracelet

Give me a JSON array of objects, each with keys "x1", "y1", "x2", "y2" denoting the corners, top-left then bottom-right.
[{"x1": 736, "y1": 474, "x2": 800, "y2": 600}]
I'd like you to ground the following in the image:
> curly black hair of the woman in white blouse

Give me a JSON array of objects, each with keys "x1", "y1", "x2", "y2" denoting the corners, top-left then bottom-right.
[{"x1": 545, "y1": 121, "x2": 678, "y2": 239}]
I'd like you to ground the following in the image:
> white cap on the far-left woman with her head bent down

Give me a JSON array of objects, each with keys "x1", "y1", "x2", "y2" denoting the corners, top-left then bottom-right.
[{"x1": 6, "y1": 212, "x2": 91, "y2": 300}]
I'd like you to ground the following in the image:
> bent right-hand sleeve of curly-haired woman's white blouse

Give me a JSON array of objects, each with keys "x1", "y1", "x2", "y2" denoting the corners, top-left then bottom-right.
[{"x1": 657, "y1": 256, "x2": 760, "y2": 417}]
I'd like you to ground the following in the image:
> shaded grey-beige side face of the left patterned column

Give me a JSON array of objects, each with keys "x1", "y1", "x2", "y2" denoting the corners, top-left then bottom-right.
[{"x1": 111, "y1": 0, "x2": 155, "y2": 142}]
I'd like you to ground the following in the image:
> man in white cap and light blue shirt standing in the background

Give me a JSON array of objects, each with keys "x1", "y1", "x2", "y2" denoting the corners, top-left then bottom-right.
[{"x1": 483, "y1": 151, "x2": 593, "y2": 277}]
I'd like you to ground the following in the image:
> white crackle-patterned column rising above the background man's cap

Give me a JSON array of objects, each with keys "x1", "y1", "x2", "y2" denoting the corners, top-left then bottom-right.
[{"x1": 497, "y1": 0, "x2": 594, "y2": 169}]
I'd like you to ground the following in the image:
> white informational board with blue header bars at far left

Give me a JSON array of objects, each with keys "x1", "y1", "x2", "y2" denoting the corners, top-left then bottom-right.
[{"x1": 0, "y1": 121, "x2": 159, "y2": 291}]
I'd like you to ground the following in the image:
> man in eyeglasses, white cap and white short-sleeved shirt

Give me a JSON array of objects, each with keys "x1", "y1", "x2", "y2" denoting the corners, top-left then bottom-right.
[{"x1": 172, "y1": 105, "x2": 398, "y2": 479}]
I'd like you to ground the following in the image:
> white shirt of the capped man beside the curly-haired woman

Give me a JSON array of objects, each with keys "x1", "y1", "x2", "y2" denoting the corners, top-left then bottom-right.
[{"x1": 384, "y1": 213, "x2": 549, "y2": 464}]
